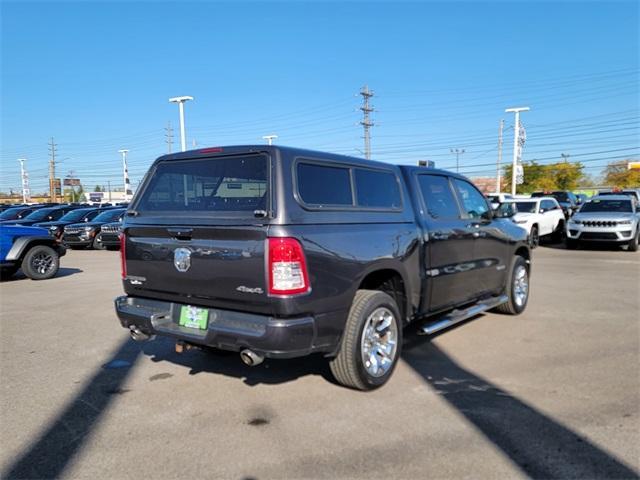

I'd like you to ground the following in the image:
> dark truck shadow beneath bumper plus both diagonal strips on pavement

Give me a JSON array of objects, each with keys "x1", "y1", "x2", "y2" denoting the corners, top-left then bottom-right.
[{"x1": 2, "y1": 332, "x2": 638, "y2": 479}]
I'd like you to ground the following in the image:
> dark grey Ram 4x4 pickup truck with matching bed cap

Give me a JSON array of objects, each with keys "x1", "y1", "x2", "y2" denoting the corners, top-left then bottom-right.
[{"x1": 115, "y1": 145, "x2": 531, "y2": 390}]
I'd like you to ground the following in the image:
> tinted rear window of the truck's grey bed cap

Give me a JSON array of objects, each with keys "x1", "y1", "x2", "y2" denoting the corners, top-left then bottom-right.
[{"x1": 134, "y1": 155, "x2": 268, "y2": 216}]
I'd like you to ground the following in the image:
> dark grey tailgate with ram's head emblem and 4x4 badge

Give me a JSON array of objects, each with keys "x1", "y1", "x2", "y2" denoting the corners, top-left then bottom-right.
[{"x1": 125, "y1": 225, "x2": 267, "y2": 311}]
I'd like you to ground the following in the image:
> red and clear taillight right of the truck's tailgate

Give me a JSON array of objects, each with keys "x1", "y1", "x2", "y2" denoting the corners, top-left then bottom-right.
[{"x1": 267, "y1": 237, "x2": 310, "y2": 295}]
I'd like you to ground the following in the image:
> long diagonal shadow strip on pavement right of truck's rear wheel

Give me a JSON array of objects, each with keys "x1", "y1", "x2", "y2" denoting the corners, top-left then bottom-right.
[{"x1": 403, "y1": 326, "x2": 639, "y2": 479}]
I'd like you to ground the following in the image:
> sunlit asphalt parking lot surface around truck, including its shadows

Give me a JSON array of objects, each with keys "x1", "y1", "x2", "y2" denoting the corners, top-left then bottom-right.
[{"x1": 0, "y1": 246, "x2": 640, "y2": 479}]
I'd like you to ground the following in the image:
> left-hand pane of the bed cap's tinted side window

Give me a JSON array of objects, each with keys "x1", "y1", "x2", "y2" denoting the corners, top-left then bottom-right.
[{"x1": 296, "y1": 162, "x2": 353, "y2": 207}]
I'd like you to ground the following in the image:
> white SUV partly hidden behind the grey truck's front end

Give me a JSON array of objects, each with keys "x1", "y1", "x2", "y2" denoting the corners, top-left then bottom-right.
[{"x1": 505, "y1": 197, "x2": 565, "y2": 248}]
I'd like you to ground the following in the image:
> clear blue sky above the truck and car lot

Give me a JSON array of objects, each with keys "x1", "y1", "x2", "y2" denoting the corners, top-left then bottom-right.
[{"x1": 0, "y1": 1, "x2": 640, "y2": 191}]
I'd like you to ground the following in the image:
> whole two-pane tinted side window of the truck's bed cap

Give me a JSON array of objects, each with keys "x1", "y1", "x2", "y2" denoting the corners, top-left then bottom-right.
[{"x1": 294, "y1": 160, "x2": 402, "y2": 210}]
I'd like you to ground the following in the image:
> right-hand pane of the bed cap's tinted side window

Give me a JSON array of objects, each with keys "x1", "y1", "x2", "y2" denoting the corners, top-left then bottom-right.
[{"x1": 354, "y1": 168, "x2": 402, "y2": 209}]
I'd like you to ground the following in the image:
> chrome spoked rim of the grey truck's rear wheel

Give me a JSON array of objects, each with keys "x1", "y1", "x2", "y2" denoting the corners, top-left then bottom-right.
[{"x1": 360, "y1": 307, "x2": 398, "y2": 377}]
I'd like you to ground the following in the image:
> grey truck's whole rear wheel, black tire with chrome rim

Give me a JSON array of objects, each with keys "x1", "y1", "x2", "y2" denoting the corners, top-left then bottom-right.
[{"x1": 329, "y1": 290, "x2": 402, "y2": 390}]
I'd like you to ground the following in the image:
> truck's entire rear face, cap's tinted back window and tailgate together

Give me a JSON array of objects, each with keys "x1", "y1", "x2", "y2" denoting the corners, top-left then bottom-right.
[{"x1": 123, "y1": 153, "x2": 271, "y2": 312}]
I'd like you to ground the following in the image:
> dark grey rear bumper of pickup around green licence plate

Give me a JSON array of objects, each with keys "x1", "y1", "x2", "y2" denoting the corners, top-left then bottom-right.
[{"x1": 115, "y1": 296, "x2": 324, "y2": 358}]
